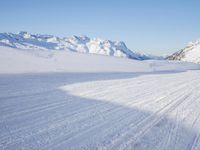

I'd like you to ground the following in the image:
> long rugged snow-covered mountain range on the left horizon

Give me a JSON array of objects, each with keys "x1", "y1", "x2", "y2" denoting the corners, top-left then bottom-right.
[{"x1": 0, "y1": 32, "x2": 150, "y2": 60}]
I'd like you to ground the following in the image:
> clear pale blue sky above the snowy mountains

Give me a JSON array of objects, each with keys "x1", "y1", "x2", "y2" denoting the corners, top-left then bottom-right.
[{"x1": 0, "y1": 0, "x2": 200, "y2": 55}]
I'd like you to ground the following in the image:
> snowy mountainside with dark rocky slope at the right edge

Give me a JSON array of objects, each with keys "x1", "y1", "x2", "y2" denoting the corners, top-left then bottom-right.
[{"x1": 167, "y1": 39, "x2": 200, "y2": 64}]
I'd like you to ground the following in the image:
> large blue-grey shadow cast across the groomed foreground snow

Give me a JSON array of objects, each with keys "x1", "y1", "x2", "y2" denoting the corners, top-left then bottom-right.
[{"x1": 0, "y1": 72, "x2": 198, "y2": 150}]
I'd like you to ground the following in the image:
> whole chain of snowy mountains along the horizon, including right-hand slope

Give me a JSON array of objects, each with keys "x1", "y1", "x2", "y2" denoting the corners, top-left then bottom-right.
[{"x1": 0, "y1": 32, "x2": 200, "y2": 63}]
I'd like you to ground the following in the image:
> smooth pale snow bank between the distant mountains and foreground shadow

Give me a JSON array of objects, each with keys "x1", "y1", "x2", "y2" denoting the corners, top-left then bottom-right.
[{"x1": 0, "y1": 46, "x2": 200, "y2": 74}]
